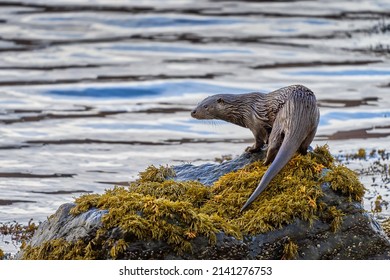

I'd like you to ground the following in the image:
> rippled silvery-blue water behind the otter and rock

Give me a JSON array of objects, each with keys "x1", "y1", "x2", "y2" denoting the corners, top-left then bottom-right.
[{"x1": 0, "y1": 0, "x2": 390, "y2": 245}]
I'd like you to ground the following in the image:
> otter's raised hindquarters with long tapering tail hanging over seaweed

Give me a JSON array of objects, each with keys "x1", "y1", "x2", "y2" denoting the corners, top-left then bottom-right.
[{"x1": 240, "y1": 90, "x2": 319, "y2": 212}]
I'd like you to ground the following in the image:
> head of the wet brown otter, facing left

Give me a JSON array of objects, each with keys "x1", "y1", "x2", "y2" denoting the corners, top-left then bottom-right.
[{"x1": 191, "y1": 94, "x2": 226, "y2": 120}]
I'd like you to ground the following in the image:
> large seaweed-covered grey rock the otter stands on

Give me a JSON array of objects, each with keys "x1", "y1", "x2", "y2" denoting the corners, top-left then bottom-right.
[{"x1": 20, "y1": 149, "x2": 390, "y2": 259}]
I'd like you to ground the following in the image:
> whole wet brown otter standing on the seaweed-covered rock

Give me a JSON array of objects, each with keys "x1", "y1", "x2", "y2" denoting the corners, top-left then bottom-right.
[{"x1": 191, "y1": 85, "x2": 320, "y2": 212}]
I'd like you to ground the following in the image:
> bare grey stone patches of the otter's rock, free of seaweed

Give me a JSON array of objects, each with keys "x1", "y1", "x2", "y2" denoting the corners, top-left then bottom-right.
[{"x1": 18, "y1": 153, "x2": 390, "y2": 259}]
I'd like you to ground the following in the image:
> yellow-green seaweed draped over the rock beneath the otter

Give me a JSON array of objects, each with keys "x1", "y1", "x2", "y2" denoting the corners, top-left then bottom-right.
[{"x1": 24, "y1": 146, "x2": 364, "y2": 259}]
